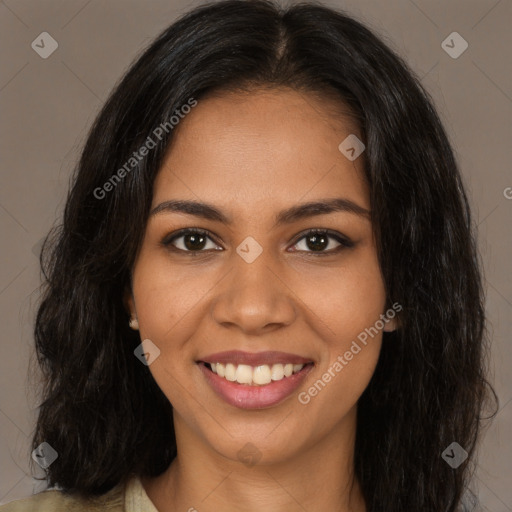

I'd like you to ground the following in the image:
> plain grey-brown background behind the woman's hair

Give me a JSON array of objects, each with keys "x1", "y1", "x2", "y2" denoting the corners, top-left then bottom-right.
[{"x1": 0, "y1": 0, "x2": 512, "y2": 512}]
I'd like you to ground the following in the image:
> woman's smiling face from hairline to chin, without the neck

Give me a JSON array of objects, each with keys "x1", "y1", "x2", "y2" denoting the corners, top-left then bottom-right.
[{"x1": 128, "y1": 89, "x2": 394, "y2": 463}]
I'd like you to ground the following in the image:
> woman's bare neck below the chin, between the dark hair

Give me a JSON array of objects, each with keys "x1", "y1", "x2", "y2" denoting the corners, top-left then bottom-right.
[{"x1": 142, "y1": 409, "x2": 366, "y2": 512}]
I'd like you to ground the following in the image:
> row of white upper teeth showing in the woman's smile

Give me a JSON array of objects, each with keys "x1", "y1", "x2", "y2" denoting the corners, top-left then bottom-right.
[{"x1": 210, "y1": 363, "x2": 304, "y2": 386}]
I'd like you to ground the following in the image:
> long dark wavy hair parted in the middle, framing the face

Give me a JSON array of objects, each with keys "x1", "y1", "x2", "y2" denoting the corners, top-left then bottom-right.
[{"x1": 33, "y1": 0, "x2": 496, "y2": 512}]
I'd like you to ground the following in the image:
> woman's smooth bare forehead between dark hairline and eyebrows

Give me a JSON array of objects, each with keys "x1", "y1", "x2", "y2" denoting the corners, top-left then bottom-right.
[{"x1": 153, "y1": 88, "x2": 369, "y2": 211}]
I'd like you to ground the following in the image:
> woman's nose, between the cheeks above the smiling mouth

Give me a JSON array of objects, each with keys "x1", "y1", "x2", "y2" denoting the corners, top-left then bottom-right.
[{"x1": 212, "y1": 250, "x2": 296, "y2": 335}]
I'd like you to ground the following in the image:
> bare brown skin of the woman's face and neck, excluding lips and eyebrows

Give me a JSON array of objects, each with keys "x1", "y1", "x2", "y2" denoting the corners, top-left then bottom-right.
[{"x1": 125, "y1": 88, "x2": 395, "y2": 512}]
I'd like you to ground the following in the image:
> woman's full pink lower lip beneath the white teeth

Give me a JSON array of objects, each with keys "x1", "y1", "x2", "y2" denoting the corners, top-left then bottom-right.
[{"x1": 198, "y1": 363, "x2": 313, "y2": 409}]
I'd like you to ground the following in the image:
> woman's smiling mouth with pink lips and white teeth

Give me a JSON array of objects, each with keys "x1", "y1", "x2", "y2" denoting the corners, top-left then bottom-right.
[{"x1": 196, "y1": 351, "x2": 314, "y2": 409}]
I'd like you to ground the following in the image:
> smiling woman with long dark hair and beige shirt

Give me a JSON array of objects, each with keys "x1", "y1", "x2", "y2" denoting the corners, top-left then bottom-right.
[{"x1": 1, "y1": 0, "x2": 492, "y2": 512}]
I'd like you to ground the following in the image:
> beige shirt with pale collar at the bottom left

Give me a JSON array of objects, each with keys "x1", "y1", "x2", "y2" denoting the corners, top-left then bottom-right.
[{"x1": 0, "y1": 477, "x2": 158, "y2": 512}]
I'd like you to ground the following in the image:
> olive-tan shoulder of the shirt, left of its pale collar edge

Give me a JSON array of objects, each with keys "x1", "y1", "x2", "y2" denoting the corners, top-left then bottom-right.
[{"x1": 0, "y1": 484, "x2": 124, "y2": 512}]
